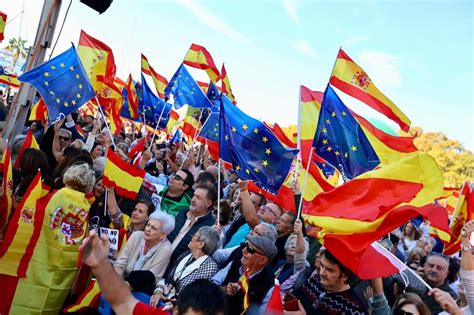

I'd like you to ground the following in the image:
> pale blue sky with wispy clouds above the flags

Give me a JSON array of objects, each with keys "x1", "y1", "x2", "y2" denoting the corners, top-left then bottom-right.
[{"x1": 0, "y1": 0, "x2": 474, "y2": 151}]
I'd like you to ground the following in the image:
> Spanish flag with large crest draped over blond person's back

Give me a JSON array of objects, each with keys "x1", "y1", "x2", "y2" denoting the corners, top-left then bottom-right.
[{"x1": 0, "y1": 187, "x2": 90, "y2": 314}]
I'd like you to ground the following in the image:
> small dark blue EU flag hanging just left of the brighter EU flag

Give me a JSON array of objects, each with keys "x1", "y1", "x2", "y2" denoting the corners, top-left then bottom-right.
[{"x1": 139, "y1": 74, "x2": 172, "y2": 128}]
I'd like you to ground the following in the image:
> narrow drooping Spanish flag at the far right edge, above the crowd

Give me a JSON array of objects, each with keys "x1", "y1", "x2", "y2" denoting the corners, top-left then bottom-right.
[{"x1": 444, "y1": 182, "x2": 474, "y2": 255}]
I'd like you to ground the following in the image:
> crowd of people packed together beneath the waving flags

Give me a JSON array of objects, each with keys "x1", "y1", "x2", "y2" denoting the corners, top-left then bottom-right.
[{"x1": 2, "y1": 109, "x2": 474, "y2": 314}]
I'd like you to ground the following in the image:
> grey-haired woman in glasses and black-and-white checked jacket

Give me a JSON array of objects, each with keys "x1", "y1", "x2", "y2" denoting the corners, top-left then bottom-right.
[{"x1": 150, "y1": 226, "x2": 219, "y2": 306}]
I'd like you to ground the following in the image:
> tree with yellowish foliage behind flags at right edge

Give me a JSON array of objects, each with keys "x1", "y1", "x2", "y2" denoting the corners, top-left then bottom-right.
[{"x1": 409, "y1": 127, "x2": 474, "y2": 188}]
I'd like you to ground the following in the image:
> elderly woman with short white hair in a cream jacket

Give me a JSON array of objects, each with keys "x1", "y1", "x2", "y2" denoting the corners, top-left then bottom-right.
[{"x1": 114, "y1": 211, "x2": 175, "y2": 294}]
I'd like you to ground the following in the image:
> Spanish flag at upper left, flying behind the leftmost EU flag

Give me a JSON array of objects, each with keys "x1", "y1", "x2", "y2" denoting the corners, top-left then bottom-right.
[{"x1": 77, "y1": 30, "x2": 116, "y2": 94}]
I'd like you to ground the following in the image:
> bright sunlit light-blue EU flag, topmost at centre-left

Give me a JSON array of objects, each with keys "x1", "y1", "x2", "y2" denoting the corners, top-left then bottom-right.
[{"x1": 165, "y1": 65, "x2": 212, "y2": 109}]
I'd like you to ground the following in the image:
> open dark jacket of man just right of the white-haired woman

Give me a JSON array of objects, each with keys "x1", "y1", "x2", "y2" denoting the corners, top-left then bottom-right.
[{"x1": 168, "y1": 209, "x2": 216, "y2": 262}]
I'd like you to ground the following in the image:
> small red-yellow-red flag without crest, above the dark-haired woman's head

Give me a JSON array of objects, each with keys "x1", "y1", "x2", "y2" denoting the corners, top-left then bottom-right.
[{"x1": 103, "y1": 149, "x2": 145, "y2": 199}]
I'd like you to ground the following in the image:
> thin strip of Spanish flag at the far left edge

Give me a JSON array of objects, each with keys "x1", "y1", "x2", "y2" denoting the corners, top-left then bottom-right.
[{"x1": 0, "y1": 142, "x2": 13, "y2": 234}]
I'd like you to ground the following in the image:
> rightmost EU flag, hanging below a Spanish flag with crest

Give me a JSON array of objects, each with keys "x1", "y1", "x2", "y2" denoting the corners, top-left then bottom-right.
[{"x1": 313, "y1": 84, "x2": 380, "y2": 180}]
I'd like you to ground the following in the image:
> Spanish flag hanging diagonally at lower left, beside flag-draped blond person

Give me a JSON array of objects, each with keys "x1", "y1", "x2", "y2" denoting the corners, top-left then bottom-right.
[{"x1": 0, "y1": 172, "x2": 45, "y2": 278}]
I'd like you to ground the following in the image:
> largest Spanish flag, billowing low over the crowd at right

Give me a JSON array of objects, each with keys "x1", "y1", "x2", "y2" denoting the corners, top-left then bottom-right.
[{"x1": 302, "y1": 154, "x2": 448, "y2": 278}]
